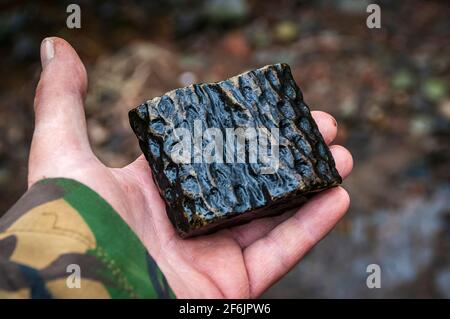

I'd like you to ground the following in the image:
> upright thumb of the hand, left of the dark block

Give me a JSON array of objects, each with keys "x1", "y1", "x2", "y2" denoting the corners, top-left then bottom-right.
[{"x1": 28, "y1": 37, "x2": 92, "y2": 185}]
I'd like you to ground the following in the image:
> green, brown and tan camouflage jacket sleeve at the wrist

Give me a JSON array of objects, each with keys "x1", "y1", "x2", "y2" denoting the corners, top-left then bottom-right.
[{"x1": 0, "y1": 178, "x2": 174, "y2": 298}]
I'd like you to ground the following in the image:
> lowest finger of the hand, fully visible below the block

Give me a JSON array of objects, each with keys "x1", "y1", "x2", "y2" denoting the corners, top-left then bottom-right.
[{"x1": 243, "y1": 187, "x2": 350, "y2": 297}]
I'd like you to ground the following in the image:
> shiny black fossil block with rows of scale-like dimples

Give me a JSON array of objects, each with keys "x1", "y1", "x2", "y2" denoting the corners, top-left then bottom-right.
[{"x1": 129, "y1": 64, "x2": 341, "y2": 237}]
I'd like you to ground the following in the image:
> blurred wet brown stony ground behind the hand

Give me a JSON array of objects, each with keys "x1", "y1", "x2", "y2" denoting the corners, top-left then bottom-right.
[{"x1": 0, "y1": 0, "x2": 450, "y2": 298}]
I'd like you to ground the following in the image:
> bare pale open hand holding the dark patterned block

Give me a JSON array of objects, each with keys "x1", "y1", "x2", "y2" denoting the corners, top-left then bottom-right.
[{"x1": 28, "y1": 37, "x2": 353, "y2": 298}]
